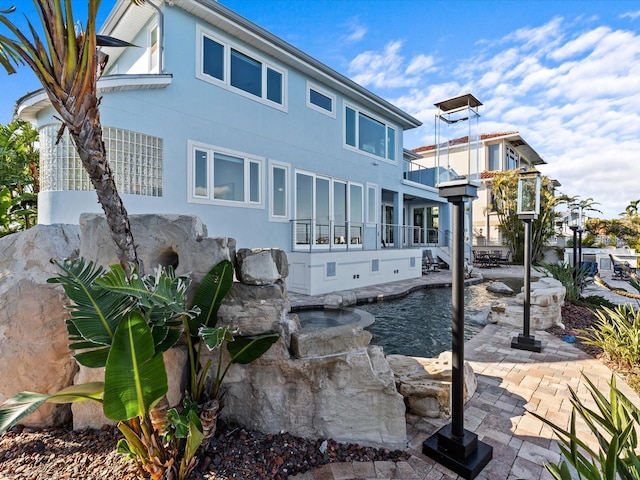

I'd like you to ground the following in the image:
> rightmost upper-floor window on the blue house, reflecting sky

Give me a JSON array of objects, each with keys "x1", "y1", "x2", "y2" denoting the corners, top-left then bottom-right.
[{"x1": 345, "y1": 106, "x2": 396, "y2": 160}]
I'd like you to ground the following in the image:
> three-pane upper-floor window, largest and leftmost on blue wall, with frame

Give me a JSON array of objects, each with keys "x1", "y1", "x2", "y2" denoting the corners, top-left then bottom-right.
[{"x1": 196, "y1": 27, "x2": 286, "y2": 108}]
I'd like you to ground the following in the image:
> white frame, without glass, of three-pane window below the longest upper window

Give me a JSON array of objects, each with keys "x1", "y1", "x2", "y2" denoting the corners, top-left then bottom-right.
[{"x1": 187, "y1": 140, "x2": 265, "y2": 208}]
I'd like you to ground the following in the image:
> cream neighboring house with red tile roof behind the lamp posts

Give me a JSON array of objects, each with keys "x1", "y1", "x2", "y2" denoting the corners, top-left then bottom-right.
[{"x1": 413, "y1": 131, "x2": 546, "y2": 253}]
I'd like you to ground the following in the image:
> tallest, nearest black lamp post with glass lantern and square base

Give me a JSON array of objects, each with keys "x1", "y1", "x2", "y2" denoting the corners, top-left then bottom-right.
[{"x1": 422, "y1": 94, "x2": 493, "y2": 480}]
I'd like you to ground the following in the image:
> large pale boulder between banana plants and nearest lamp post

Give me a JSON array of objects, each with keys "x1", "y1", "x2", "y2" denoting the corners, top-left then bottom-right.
[{"x1": 214, "y1": 335, "x2": 407, "y2": 448}]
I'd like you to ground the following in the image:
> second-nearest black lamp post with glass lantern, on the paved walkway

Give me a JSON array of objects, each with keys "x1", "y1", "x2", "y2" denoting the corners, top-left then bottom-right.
[{"x1": 511, "y1": 168, "x2": 542, "y2": 352}]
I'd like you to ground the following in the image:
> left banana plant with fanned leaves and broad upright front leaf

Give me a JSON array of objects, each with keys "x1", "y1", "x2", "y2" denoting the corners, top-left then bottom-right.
[{"x1": 0, "y1": 258, "x2": 198, "y2": 479}]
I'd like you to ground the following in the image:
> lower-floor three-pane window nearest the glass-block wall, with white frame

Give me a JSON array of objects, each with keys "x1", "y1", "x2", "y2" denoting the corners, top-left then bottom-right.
[{"x1": 189, "y1": 142, "x2": 263, "y2": 207}]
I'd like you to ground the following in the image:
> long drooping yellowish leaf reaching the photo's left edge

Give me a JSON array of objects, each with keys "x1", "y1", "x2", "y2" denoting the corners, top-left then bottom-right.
[{"x1": 0, "y1": 382, "x2": 104, "y2": 435}]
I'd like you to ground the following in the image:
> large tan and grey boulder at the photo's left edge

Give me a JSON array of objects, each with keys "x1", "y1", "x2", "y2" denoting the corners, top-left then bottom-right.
[{"x1": 0, "y1": 225, "x2": 80, "y2": 426}]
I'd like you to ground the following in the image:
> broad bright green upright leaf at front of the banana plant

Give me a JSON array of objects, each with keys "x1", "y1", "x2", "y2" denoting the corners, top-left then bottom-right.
[{"x1": 104, "y1": 311, "x2": 167, "y2": 421}]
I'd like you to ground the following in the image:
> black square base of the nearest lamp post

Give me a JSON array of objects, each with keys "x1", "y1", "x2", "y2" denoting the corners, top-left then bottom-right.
[{"x1": 422, "y1": 424, "x2": 493, "y2": 480}]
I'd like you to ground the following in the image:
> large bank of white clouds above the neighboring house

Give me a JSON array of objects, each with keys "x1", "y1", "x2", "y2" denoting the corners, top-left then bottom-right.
[{"x1": 392, "y1": 15, "x2": 640, "y2": 218}]
